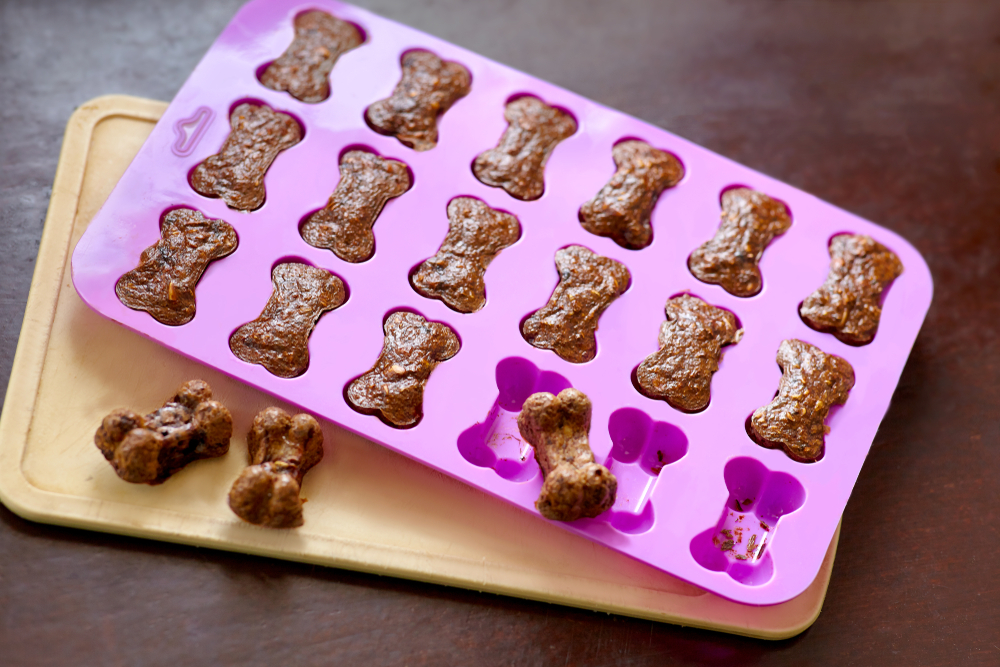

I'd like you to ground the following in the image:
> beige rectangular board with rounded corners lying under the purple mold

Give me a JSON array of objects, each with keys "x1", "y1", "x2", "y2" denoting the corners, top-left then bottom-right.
[{"x1": 0, "y1": 96, "x2": 840, "y2": 639}]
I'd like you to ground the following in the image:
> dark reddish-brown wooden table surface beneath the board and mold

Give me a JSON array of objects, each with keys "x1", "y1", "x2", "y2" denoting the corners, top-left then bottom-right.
[{"x1": 0, "y1": 0, "x2": 1000, "y2": 666}]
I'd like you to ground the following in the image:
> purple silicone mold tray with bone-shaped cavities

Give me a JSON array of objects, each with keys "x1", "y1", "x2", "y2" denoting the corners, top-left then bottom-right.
[{"x1": 73, "y1": 0, "x2": 932, "y2": 604}]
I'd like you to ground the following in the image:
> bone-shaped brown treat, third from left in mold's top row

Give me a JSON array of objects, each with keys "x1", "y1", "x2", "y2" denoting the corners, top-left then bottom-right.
[{"x1": 472, "y1": 95, "x2": 576, "y2": 201}]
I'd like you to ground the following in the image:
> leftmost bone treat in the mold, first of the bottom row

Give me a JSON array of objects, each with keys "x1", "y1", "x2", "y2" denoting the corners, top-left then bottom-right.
[{"x1": 115, "y1": 208, "x2": 238, "y2": 326}]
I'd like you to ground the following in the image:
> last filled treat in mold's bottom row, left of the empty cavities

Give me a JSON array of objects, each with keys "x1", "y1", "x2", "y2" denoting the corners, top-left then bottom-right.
[{"x1": 347, "y1": 311, "x2": 460, "y2": 428}]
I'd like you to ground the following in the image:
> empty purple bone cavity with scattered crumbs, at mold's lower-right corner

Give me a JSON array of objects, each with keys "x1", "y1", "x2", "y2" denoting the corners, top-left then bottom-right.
[{"x1": 690, "y1": 457, "x2": 806, "y2": 586}]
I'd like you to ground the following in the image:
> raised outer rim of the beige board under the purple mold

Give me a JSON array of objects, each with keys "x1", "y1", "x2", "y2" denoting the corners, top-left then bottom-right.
[{"x1": 0, "y1": 95, "x2": 840, "y2": 640}]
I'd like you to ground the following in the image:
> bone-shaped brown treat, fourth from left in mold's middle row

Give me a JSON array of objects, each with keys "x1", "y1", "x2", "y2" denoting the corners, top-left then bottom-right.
[{"x1": 521, "y1": 245, "x2": 632, "y2": 364}]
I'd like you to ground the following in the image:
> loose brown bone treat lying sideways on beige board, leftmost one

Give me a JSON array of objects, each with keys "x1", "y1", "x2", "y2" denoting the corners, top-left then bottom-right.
[{"x1": 94, "y1": 380, "x2": 233, "y2": 484}]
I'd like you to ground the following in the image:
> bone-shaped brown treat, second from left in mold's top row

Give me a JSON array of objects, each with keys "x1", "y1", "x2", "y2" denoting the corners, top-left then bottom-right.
[{"x1": 365, "y1": 49, "x2": 472, "y2": 151}]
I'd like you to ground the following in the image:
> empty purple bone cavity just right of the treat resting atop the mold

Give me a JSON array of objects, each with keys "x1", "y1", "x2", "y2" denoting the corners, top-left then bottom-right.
[{"x1": 604, "y1": 408, "x2": 688, "y2": 534}]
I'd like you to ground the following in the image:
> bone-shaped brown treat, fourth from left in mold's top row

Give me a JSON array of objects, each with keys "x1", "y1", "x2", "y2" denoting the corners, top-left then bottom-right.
[{"x1": 580, "y1": 140, "x2": 684, "y2": 250}]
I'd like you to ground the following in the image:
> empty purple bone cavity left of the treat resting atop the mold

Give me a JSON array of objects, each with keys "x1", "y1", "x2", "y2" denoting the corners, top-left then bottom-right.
[{"x1": 458, "y1": 357, "x2": 572, "y2": 482}]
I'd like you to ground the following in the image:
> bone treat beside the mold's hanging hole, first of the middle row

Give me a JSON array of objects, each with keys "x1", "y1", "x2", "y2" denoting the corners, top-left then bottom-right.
[{"x1": 191, "y1": 102, "x2": 302, "y2": 211}]
